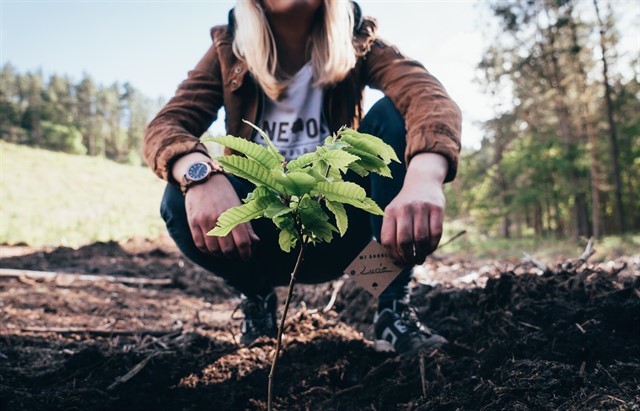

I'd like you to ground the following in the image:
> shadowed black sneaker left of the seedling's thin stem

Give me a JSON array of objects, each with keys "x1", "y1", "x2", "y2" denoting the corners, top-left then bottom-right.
[{"x1": 240, "y1": 292, "x2": 278, "y2": 345}]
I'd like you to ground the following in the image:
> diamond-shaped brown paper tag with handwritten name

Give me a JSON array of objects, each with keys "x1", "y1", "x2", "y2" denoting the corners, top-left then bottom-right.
[{"x1": 344, "y1": 240, "x2": 403, "y2": 297}]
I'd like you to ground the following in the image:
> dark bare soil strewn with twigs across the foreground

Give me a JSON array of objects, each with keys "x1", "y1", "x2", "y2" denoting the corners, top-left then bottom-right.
[{"x1": 0, "y1": 240, "x2": 640, "y2": 411}]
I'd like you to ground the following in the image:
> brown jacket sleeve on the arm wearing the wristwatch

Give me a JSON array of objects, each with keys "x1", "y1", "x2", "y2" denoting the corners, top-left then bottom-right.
[{"x1": 143, "y1": 34, "x2": 223, "y2": 183}]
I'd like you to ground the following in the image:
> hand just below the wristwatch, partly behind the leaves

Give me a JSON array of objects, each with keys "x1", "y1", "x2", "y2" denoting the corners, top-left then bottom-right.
[{"x1": 185, "y1": 174, "x2": 260, "y2": 261}]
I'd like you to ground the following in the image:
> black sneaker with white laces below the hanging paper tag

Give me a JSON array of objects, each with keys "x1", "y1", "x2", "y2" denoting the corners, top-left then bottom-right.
[{"x1": 373, "y1": 300, "x2": 448, "y2": 354}]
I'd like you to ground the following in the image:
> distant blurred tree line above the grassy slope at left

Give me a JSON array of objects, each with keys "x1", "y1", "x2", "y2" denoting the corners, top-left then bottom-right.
[{"x1": 0, "y1": 63, "x2": 162, "y2": 165}]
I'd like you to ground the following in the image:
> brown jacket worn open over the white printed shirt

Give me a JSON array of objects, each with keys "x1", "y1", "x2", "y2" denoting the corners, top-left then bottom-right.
[{"x1": 143, "y1": 6, "x2": 461, "y2": 182}]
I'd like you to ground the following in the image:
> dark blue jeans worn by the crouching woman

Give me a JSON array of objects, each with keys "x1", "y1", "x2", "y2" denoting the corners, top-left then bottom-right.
[{"x1": 160, "y1": 97, "x2": 410, "y2": 299}]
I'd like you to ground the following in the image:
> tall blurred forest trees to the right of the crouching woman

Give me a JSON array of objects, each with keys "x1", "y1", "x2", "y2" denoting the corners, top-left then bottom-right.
[{"x1": 447, "y1": 0, "x2": 640, "y2": 240}]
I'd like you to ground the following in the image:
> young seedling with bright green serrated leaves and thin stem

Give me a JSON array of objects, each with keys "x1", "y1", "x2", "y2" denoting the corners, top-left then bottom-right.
[{"x1": 202, "y1": 121, "x2": 400, "y2": 410}]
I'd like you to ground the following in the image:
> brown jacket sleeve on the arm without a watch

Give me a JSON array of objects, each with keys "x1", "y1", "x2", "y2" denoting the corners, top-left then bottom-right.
[{"x1": 363, "y1": 39, "x2": 462, "y2": 182}]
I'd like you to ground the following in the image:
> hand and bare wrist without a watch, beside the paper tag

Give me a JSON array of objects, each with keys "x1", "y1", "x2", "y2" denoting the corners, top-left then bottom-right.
[{"x1": 380, "y1": 153, "x2": 447, "y2": 266}]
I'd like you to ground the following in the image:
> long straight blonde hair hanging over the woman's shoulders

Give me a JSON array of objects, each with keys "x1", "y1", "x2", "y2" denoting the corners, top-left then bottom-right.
[{"x1": 233, "y1": 0, "x2": 356, "y2": 100}]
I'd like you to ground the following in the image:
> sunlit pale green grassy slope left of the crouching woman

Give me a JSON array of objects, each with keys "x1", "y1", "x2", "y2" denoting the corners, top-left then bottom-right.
[{"x1": 0, "y1": 141, "x2": 165, "y2": 247}]
